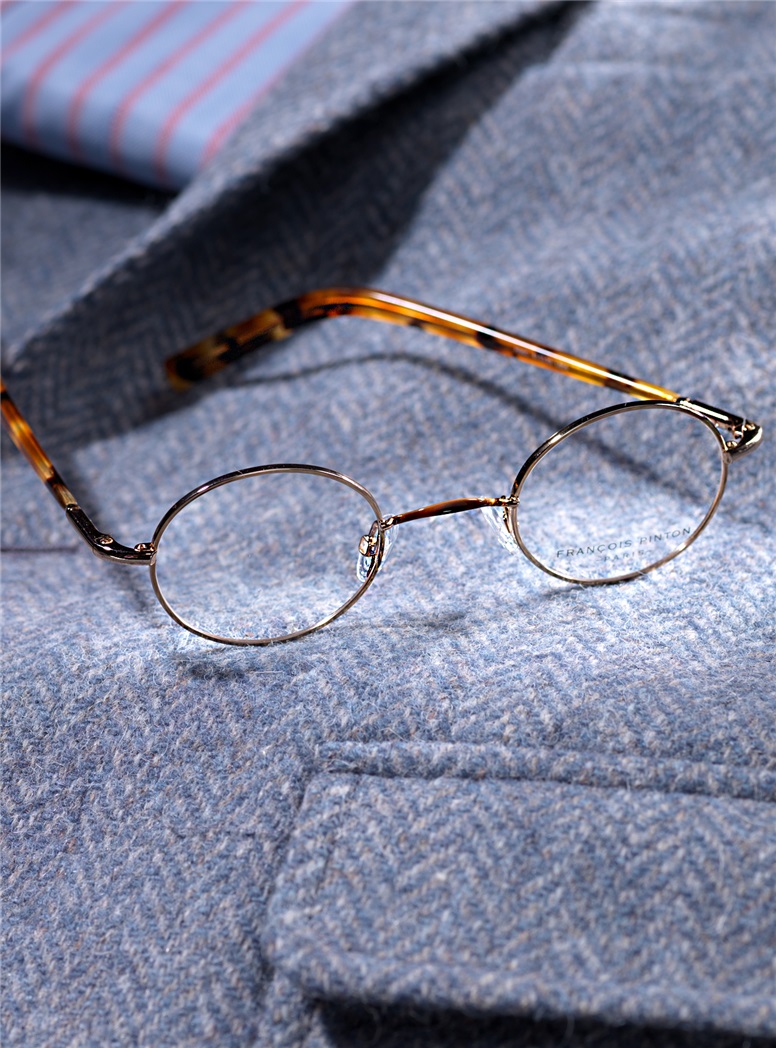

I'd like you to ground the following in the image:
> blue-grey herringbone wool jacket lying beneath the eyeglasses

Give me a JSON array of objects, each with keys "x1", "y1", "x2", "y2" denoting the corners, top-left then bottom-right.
[{"x1": 0, "y1": 0, "x2": 776, "y2": 1048}]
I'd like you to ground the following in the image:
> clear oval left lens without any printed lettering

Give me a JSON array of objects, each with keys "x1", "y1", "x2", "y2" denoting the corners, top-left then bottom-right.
[{"x1": 151, "y1": 466, "x2": 380, "y2": 643}]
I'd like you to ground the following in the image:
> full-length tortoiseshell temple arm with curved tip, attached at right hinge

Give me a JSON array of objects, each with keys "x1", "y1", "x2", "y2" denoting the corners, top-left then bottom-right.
[{"x1": 167, "y1": 287, "x2": 762, "y2": 454}]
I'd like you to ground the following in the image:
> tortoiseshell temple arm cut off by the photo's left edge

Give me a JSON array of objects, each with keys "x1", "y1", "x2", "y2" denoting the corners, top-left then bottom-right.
[{"x1": 0, "y1": 381, "x2": 154, "y2": 564}]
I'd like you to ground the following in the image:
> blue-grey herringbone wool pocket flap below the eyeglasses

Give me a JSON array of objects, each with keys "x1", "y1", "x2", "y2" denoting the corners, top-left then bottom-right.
[{"x1": 266, "y1": 747, "x2": 776, "y2": 1034}]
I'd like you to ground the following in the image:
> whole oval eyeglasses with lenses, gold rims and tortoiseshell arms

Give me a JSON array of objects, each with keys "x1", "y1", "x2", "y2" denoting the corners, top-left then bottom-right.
[{"x1": 0, "y1": 288, "x2": 762, "y2": 645}]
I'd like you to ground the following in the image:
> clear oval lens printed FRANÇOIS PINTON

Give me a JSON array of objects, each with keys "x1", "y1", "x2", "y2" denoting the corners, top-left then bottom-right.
[{"x1": 513, "y1": 402, "x2": 727, "y2": 583}]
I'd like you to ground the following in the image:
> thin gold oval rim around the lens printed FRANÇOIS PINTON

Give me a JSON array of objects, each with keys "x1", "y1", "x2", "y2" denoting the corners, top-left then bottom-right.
[{"x1": 505, "y1": 400, "x2": 730, "y2": 586}]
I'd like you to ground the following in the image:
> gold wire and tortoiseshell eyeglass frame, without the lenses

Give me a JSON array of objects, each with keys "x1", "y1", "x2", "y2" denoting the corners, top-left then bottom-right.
[{"x1": 0, "y1": 287, "x2": 762, "y2": 645}]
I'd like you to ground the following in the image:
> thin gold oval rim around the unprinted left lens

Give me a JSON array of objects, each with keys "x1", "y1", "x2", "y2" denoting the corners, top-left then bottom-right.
[{"x1": 150, "y1": 463, "x2": 385, "y2": 647}]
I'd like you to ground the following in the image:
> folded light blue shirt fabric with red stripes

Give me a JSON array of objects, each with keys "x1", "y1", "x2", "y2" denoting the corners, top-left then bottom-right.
[{"x1": 0, "y1": 0, "x2": 352, "y2": 189}]
